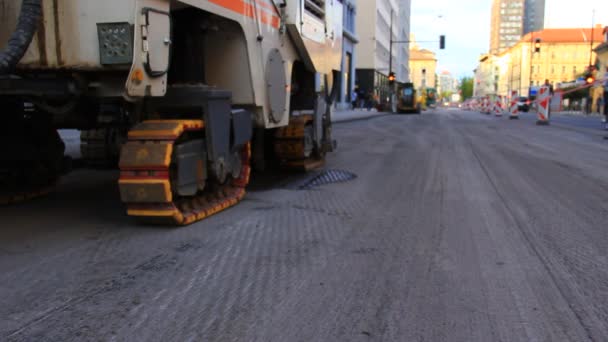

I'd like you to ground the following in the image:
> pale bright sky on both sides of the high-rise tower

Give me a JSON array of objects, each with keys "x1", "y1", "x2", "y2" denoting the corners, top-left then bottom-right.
[{"x1": 408, "y1": 0, "x2": 608, "y2": 78}]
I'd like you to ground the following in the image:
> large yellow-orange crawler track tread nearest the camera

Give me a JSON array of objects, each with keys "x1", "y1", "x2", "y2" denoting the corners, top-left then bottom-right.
[{"x1": 118, "y1": 120, "x2": 251, "y2": 225}]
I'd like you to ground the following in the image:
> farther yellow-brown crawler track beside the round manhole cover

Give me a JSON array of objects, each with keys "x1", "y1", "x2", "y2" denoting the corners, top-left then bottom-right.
[{"x1": 274, "y1": 114, "x2": 325, "y2": 171}]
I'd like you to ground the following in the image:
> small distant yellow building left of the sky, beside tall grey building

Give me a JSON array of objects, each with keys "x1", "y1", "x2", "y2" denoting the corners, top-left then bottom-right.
[{"x1": 410, "y1": 38, "x2": 437, "y2": 89}]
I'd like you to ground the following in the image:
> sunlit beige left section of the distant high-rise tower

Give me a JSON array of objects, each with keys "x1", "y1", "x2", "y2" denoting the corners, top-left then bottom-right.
[{"x1": 490, "y1": 0, "x2": 530, "y2": 54}]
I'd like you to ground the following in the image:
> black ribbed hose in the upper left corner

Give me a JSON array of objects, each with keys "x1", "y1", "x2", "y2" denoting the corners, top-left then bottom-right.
[{"x1": 0, "y1": 0, "x2": 42, "y2": 75}]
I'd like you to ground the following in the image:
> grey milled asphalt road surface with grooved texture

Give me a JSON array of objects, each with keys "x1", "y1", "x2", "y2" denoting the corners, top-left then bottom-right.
[{"x1": 0, "y1": 110, "x2": 608, "y2": 342}]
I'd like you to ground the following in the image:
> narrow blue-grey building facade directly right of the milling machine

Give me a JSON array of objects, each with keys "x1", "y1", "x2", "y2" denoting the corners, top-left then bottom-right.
[{"x1": 335, "y1": 0, "x2": 359, "y2": 109}]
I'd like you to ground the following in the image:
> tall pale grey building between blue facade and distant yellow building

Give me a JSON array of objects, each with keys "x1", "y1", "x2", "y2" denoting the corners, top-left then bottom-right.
[{"x1": 355, "y1": 0, "x2": 411, "y2": 107}]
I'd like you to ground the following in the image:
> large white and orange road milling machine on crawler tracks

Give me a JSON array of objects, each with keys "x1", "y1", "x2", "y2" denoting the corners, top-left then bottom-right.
[{"x1": 0, "y1": 0, "x2": 342, "y2": 225}]
